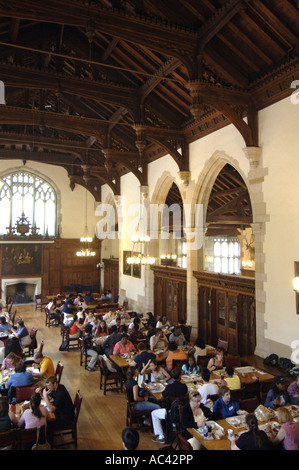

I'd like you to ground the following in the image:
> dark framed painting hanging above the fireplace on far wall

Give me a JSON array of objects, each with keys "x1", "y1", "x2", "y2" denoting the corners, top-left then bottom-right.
[{"x1": 1, "y1": 243, "x2": 42, "y2": 276}]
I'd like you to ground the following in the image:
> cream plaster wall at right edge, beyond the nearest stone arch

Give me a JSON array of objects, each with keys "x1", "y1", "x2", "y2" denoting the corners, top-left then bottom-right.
[{"x1": 260, "y1": 98, "x2": 299, "y2": 346}]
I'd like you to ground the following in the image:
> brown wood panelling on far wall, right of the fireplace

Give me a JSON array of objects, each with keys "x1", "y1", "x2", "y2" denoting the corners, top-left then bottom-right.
[{"x1": 0, "y1": 238, "x2": 101, "y2": 296}]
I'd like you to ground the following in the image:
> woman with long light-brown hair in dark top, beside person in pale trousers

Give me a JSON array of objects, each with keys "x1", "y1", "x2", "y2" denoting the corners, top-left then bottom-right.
[{"x1": 181, "y1": 389, "x2": 217, "y2": 450}]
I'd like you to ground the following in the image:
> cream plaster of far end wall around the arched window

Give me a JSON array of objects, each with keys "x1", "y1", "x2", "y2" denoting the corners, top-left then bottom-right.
[{"x1": 0, "y1": 160, "x2": 96, "y2": 238}]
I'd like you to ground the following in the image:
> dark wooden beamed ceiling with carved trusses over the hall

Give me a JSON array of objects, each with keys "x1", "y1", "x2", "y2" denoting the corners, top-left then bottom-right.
[{"x1": 0, "y1": 0, "x2": 299, "y2": 200}]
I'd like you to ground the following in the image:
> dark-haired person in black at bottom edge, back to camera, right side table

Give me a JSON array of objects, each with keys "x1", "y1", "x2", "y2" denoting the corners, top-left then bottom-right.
[{"x1": 231, "y1": 414, "x2": 273, "y2": 450}]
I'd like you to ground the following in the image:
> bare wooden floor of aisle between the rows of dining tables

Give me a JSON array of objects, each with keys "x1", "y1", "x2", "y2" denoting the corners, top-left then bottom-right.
[{"x1": 13, "y1": 304, "x2": 157, "y2": 450}]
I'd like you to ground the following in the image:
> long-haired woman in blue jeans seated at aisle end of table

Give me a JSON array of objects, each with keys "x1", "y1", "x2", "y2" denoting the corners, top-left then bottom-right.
[{"x1": 126, "y1": 367, "x2": 160, "y2": 425}]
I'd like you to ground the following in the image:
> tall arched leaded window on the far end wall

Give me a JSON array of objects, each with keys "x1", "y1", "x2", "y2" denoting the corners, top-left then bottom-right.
[{"x1": 0, "y1": 171, "x2": 56, "y2": 236}]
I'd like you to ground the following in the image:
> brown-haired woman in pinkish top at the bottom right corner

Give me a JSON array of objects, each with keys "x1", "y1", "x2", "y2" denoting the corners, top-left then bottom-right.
[{"x1": 267, "y1": 406, "x2": 299, "y2": 450}]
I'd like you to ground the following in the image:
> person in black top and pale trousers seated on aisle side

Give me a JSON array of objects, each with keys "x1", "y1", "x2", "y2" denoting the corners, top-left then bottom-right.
[{"x1": 151, "y1": 367, "x2": 188, "y2": 444}]
